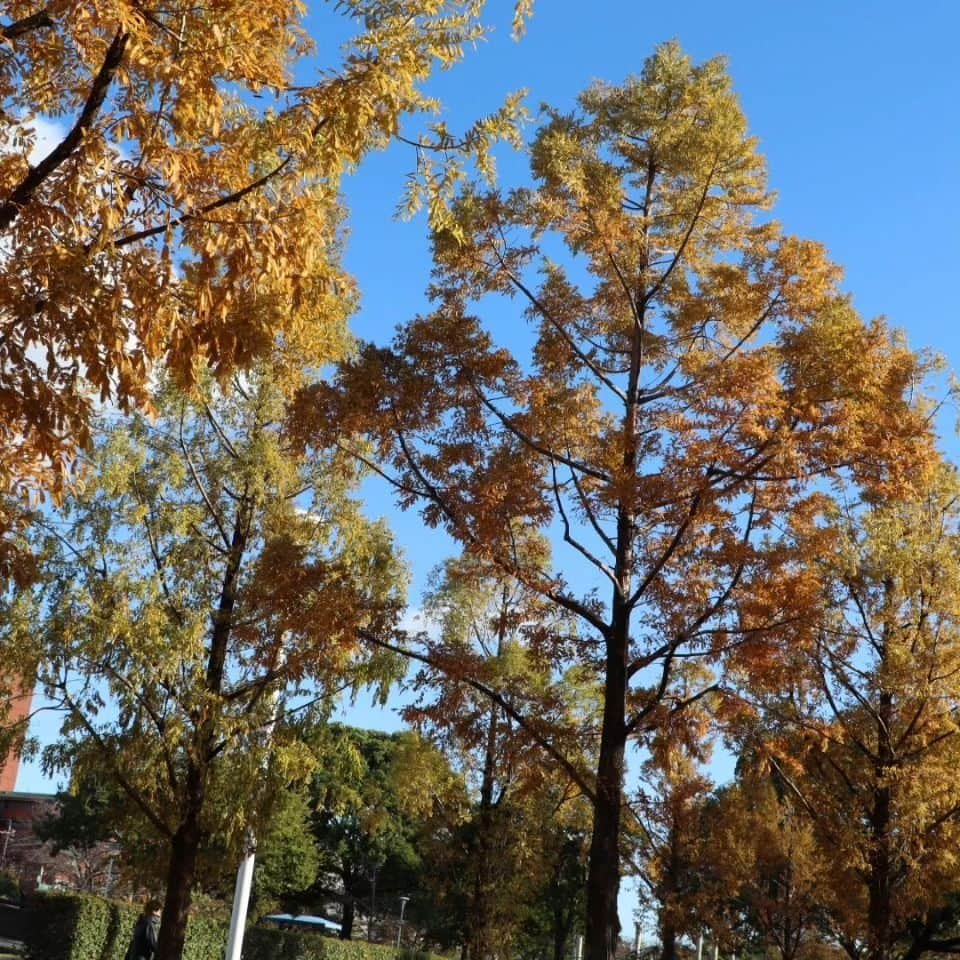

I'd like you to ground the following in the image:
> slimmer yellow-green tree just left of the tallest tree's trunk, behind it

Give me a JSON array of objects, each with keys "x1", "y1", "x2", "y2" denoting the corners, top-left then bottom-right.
[{"x1": 376, "y1": 548, "x2": 589, "y2": 958}]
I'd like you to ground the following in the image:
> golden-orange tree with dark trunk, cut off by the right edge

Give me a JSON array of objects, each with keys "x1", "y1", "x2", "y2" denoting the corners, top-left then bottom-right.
[{"x1": 753, "y1": 466, "x2": 960, "y2": 960}]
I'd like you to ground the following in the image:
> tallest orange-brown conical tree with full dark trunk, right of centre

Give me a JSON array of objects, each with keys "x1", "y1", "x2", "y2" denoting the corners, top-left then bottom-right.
[{"x1": 300, "y1": 44, "x2": 927, "y2": 960}]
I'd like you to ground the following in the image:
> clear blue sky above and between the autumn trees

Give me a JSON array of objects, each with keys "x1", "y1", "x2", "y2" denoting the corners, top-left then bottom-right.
[{"x1": 13, "y1": 0, "x2": 960, "y2": 925}]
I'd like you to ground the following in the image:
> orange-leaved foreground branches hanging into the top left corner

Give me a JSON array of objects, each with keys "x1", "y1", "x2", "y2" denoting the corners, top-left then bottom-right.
[{"x1": 0, "y1": 0, "x2": 526, "y2": 516}]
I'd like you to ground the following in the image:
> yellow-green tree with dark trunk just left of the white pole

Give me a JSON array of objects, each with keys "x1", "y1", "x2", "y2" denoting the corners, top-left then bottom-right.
[{"x1": 2, "y1": 367, "x2": 404, "y2": 960}]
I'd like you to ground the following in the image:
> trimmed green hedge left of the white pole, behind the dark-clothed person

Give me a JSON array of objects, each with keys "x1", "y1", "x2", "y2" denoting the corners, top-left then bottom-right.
[{"x1": 26, "y1": 893, "x2": 227, "y2": 960}]
